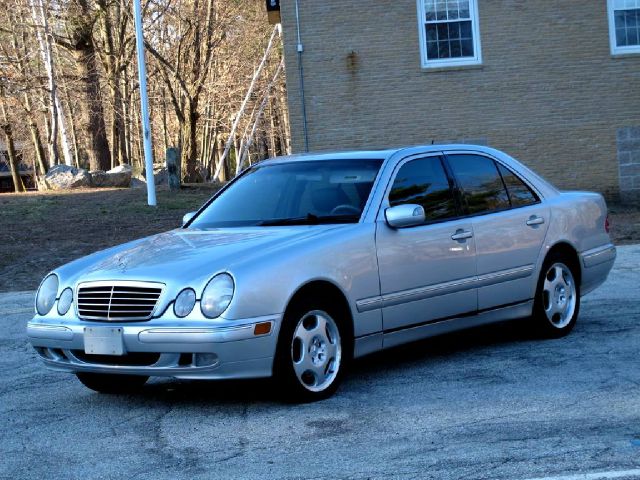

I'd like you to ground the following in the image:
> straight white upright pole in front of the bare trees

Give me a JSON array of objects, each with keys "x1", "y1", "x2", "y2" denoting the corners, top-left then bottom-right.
[{"x1": 133, "y1": 0, "x2": 156, "y2": 206}]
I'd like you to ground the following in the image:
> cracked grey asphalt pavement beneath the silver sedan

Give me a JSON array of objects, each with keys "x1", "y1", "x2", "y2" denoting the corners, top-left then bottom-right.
[{"x1": 0, "y1": 245, "x2": 640, "y2": 480}]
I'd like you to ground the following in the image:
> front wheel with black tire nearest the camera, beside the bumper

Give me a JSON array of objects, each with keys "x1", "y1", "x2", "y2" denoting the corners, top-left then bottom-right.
[{"x1": 274, "y1": 301, "x2": 353, "y2": 403}]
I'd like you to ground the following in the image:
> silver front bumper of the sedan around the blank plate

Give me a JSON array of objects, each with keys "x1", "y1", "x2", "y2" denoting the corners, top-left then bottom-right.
[{"x1": 27, "y1": 315, "x2": 281, "y2": 379}]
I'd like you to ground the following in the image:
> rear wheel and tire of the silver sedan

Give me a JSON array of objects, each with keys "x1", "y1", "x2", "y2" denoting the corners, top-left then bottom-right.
[{"x1": 532, "y1": 252, "x2": 580, "y2": 338}]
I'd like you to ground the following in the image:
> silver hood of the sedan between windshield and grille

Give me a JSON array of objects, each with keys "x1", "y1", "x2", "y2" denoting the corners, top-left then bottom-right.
[{"x1": 57, "y1": 225, "x2": 345, "y2": 287}]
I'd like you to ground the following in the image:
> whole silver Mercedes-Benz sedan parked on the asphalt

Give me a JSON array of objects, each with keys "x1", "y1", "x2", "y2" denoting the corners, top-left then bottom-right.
[{"x1": 27, "y1": 145, "x2": 616, "y2": 401}]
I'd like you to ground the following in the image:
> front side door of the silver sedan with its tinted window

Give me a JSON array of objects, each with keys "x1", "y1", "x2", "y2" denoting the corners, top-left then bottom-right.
[{"x1": 376, "y1": 155, "x2": 477, "y2": 332}]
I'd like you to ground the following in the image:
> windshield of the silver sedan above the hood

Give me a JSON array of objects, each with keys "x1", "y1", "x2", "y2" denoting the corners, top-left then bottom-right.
[{"x1": 190, "y1": 160, "x2": 382, "y2": 228}]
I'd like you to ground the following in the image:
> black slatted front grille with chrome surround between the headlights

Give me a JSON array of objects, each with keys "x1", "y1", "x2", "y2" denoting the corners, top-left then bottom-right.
[{"x1": 77, "y1": 282, "x2": 162, "y2": 322}]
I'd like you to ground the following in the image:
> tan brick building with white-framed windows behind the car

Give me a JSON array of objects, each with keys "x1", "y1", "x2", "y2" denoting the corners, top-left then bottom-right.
[{"x1": 278, "y1": 0, "x2": 640, "y2": 200}]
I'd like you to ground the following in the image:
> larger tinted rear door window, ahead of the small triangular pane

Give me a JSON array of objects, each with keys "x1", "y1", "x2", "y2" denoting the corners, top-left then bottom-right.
[{"x1": 447, "y1": 154, "x2": 511, "y2": 215}]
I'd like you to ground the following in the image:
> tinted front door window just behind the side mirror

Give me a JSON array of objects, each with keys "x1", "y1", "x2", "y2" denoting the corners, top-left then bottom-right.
[{"x1": 389, "y1": 157, "x2": 458, "y2": 222}]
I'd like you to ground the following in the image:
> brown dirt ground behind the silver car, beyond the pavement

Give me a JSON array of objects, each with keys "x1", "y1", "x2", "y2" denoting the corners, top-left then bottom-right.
[{"x1": 0, "y1": 185, "x2": 640, "y2": 292}]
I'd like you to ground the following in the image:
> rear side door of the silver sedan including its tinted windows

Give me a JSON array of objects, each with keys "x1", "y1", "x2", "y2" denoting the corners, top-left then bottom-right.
[{"x1": 447, "y1": 153, "x2": 549, "y2": 310}]
